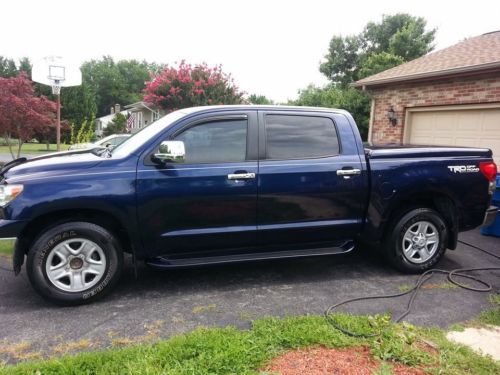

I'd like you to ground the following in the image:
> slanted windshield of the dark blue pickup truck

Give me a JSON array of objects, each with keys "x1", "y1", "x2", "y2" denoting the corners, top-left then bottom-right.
[{"x1": 113, "y1": 111, "x2": 186, "y2": 158}]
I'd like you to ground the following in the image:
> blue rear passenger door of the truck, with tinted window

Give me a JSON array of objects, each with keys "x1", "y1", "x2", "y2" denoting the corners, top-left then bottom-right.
[{"x1": 257, "y1": 111, "x2": 368, "y2": 246}]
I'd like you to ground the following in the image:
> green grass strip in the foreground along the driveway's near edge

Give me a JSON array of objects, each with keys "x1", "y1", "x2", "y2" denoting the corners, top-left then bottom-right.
[{"x1": 0, "y1": 314, "x2": 500, "y2": 375}]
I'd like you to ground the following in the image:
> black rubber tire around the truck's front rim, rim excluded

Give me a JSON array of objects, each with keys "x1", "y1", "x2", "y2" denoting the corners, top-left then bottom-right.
[{"x1": 27, "y1": 222, "x2": 123, "y2": 305}]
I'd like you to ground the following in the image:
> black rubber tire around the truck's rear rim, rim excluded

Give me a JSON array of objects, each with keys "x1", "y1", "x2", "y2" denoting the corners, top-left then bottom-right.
[{"x1": 386, "y1": 208, "x2": 448, "y2": 273}]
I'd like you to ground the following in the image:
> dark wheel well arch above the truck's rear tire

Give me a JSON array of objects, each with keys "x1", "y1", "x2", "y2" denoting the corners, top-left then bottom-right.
[{"x1": 384, "y1": 192, "x2": 460, "y2": 250}]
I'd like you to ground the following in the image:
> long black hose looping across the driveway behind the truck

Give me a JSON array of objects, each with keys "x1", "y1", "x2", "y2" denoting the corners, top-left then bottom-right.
[{"x1": 325, "y1": 241, "x2": 500, "y2": 338}]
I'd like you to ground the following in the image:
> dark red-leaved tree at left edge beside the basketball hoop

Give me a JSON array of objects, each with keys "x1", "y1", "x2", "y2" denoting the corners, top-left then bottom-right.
[{"x1": 0, "y1": 73, "x2": 56, "y2": 158}]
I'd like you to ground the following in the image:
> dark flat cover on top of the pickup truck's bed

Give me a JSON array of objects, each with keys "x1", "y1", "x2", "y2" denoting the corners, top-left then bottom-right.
[{"x1": 365, "y1": 144, "x2": 492, "y2": 159}]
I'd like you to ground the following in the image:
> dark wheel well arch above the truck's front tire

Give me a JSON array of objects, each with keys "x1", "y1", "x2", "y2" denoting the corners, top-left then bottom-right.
[{"x1": 17, "y1": 209, "x2": 132, "y2": 254}]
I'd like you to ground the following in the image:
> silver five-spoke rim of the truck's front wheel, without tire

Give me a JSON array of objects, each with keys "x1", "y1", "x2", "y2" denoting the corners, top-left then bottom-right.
[{"x1": 45, "y1": 238, "x2": 106, "y2": 292}]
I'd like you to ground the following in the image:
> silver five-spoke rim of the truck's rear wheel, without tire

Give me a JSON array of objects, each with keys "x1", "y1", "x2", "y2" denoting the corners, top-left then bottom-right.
[{"x1": 402, "y1": 221, "x2": 439, "y2": 263}]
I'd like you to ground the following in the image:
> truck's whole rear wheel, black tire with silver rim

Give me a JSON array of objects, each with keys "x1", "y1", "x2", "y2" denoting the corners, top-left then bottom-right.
[{"x1": 384, "y1": 208, "x2": 448, "y2": 273}]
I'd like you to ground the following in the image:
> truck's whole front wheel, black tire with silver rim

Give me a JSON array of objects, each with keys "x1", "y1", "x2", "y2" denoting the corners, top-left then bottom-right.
[{"x1": 27, "y1": 222, "x2": 123, "y2": 305}]
